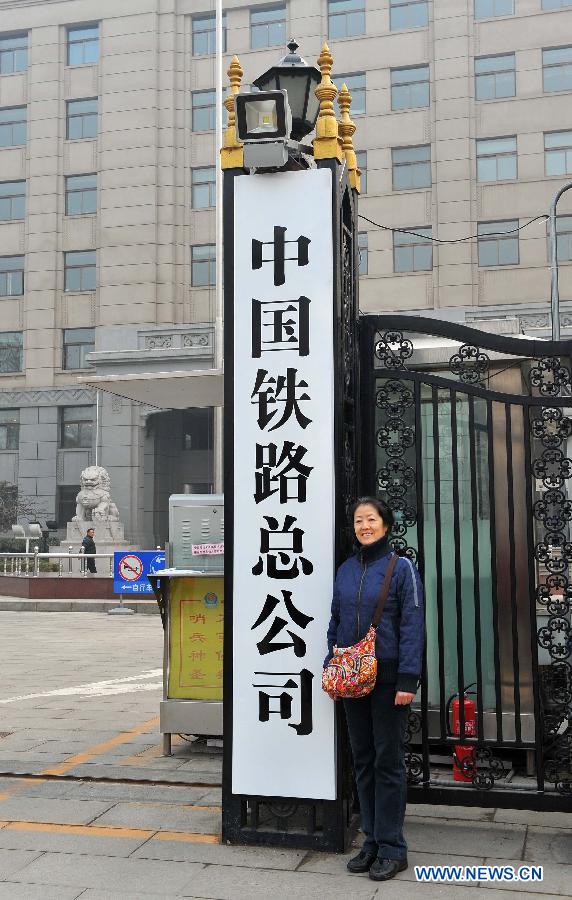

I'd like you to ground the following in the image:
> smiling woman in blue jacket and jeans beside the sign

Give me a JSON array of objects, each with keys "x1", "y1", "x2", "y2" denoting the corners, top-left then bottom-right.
[{"x1": 324, "y1": 497, "x2": 425, "y2": 881}]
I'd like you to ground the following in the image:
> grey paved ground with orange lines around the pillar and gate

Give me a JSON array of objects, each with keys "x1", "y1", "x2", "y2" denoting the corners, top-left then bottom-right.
[{"x1": 0, "y1": 612, "x2": 572, "y2": 900}]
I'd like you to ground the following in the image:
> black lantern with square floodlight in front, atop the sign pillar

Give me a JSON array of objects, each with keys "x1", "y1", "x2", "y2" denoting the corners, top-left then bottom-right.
[{"x1": 235, "y1": 40, "x2": 321, "y2": 169}]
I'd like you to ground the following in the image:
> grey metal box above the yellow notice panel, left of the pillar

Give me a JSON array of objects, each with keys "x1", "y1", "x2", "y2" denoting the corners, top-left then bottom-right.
[{"x1": 169, "y1": 494, "x2": 224, "y2": 572}]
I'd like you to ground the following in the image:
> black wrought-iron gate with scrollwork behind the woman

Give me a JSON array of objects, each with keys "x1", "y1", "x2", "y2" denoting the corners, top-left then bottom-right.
[{"x1": 360, "y1": 315, "x2": 572, "y2": 810}]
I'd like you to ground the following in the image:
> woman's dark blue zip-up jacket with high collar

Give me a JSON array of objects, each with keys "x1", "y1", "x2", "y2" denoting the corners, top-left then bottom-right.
[{"x1": 324, "y1": 542, "x2": 425, "y2": 693}]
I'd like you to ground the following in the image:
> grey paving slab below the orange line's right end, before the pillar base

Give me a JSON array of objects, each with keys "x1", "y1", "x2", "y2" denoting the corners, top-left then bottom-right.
[{"x1": 132, "y1": 833, "x2": 306, "y2": 871}]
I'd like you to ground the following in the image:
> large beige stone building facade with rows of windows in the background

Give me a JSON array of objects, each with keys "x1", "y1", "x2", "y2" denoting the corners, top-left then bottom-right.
[{"x1": 0, "y1": 0, "x2": 572, "y2": 546}]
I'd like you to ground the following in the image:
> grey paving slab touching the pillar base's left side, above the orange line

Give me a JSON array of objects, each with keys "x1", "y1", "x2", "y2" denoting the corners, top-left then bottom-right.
[{"x1": 91, "y1": 803, "x2": 221, "y2": 834}]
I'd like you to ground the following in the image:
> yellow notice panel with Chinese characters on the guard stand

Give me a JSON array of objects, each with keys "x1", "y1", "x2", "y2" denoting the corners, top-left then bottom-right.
[{"x1": 168, "y1": 575, "x2": 224, "y2": 700}]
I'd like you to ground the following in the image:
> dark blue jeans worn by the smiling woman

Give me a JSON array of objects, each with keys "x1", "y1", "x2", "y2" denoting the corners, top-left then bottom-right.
[{"x1": 343, "y1": 681, "x2": 410, "y2": 859}]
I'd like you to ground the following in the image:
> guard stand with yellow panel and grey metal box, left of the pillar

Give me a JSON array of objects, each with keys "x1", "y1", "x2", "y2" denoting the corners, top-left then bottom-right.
[{"x1": 149, "y1": 494, "x2": 224, "y2": 755}]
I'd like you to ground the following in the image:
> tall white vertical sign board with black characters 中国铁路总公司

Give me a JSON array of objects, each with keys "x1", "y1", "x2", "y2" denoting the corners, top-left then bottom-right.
[{"x1": 232, "y1": 169, "x2": 336, "y2": 800}]
